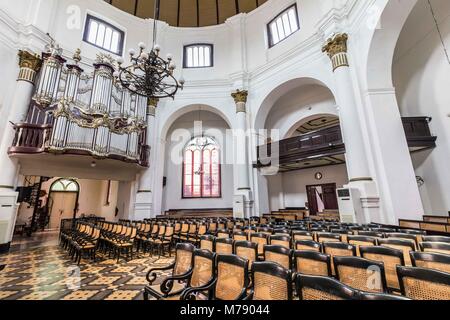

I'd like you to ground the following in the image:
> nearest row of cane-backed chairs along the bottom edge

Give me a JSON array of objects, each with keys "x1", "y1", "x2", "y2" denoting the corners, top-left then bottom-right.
[{"x1": 144, "y1": 244, "x2": 450, "y2": 300}]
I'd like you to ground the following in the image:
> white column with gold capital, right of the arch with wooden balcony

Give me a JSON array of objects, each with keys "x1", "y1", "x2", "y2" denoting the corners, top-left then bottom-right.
[{"x1": 322, "y1": 33, "x2": 382, "y2": 223}]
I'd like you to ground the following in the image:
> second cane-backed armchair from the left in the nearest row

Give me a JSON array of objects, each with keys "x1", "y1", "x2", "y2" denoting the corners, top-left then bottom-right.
[{"x1": 162, "y1": 249, "x2": 216, "y2": 300}]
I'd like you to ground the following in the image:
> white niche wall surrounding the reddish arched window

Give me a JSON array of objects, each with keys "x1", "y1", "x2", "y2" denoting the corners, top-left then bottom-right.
[{"x1": 163, "y1": 111, "x2": 234, "y2": 211}]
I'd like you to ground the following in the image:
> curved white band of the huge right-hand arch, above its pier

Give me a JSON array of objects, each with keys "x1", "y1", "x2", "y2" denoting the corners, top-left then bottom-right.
[{"x1": 366, "y1": 0, "x2": 418, "y2": 90}]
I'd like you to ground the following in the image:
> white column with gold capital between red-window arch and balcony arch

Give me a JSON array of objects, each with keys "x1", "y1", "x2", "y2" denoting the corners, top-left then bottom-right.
[{"x1": 231, "y1": 90, "x2": 254, "y2": 218}]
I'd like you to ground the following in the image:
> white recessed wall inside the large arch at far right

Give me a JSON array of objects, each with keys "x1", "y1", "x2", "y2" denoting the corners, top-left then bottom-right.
[{"x1": 393, "y1": 0, "x2": 450, "y2": 215}]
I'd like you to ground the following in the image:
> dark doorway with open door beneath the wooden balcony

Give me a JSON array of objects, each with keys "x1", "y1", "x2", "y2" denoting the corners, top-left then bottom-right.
[{"x1": 306, "y1": 183, "x2": 339, "y2": 216}]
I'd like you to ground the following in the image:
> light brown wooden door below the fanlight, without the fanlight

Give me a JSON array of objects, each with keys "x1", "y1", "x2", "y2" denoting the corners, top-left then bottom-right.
[{"x1": 49, "y1": 192, "x2": 77, "y2": 229}]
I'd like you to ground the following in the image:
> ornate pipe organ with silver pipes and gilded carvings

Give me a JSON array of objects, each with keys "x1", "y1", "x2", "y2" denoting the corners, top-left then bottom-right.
[{"x1": 27, "y1": 51, "x2": 148, "y2": 165}]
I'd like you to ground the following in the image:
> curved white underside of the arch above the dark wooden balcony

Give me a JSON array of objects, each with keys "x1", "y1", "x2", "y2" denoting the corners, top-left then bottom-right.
[{"x1": 254, "y1": 77, "x2": 336, "y2": 130}]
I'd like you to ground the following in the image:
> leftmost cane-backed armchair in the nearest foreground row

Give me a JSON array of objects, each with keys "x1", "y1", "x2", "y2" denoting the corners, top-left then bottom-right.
[{"x1": 144, "y1": 243, "x2": 195, "y2": 300}]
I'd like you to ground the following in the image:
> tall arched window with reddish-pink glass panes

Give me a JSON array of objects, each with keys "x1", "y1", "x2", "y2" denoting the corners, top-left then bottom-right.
[{"x1": 183, "y1": 137, "x2": 222, "y2": 198}]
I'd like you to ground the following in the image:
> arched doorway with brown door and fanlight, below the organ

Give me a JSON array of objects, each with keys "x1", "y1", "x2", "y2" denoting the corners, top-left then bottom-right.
[{"x1": 47, "y1": 179, "x2": 80, "y2": 229}]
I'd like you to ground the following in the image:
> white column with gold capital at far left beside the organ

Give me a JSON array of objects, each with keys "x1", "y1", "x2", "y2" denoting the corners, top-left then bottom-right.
[{"x1": 0, "y1": 51, "x2": 42, "y2": 253}]
